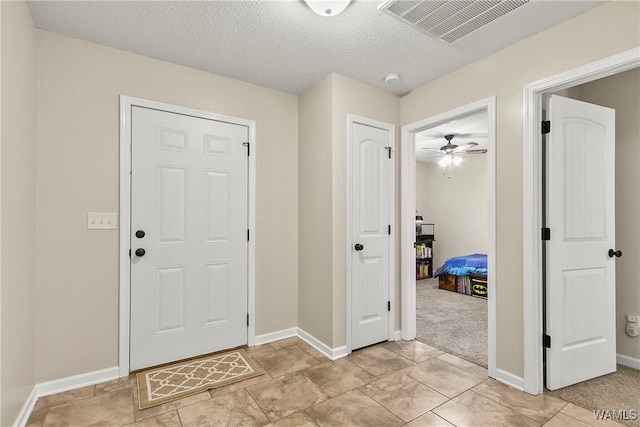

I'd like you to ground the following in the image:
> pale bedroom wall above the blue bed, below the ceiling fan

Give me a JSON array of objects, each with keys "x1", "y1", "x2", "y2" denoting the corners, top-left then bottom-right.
[{"x1": 416, "y1": 155, "x2": 489, "y2": 269}]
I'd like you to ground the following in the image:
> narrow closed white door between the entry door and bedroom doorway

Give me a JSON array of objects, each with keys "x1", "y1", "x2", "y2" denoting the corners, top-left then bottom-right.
[{"x1": 350, "y1": 118, "x2": 395, "y2": 350}]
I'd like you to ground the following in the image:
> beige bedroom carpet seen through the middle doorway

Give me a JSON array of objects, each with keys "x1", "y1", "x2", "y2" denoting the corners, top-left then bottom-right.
[{"x1": 416, "y1": 279, "x2": 488, "y2": 368}]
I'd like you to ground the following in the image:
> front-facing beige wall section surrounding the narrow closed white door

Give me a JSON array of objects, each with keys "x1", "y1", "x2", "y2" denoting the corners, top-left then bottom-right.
[{"x1": 332, "y1": 74, "x2": 400, "y2": 348}]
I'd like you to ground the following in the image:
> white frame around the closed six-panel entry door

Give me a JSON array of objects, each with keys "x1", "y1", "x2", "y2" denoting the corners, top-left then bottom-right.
[{"x1": 118, "y1": 95, "x2": 257, "y2": 377}]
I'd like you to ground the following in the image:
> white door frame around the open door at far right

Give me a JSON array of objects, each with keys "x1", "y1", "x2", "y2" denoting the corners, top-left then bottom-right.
[{"x1": 522, "y1": 48, "x2": 640, "y2": 394}]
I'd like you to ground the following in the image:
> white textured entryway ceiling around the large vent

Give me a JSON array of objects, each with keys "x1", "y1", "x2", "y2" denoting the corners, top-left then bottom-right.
[{"x1": 28, "y1": 0, "x2": 602, "y2": 95}]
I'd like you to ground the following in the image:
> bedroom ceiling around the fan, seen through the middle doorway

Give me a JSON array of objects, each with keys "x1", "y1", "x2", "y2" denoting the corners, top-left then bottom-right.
[{"x1": 416, "y1": 110, "x2": 489, "y2": 163}]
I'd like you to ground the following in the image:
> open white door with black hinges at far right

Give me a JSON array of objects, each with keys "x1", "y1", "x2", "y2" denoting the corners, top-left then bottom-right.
[{"x1": 546, "y1": 96, "x2": 616, "y2": 390}]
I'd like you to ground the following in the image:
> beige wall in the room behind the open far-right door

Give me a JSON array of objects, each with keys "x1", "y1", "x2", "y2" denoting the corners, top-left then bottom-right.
[{"x1": 573, "y1": 68, "x2": 640, "y2": 359}]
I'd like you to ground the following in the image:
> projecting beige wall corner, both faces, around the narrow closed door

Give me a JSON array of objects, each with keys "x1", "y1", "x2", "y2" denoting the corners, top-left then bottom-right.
[{"x1": 298, "y1": 73, "x2": 400, "y2": 348}]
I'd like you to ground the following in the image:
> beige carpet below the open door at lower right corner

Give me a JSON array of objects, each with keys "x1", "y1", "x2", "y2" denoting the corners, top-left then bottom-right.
[{"x1": 545, "y1": 365, "x2": 640, "y2": 427}]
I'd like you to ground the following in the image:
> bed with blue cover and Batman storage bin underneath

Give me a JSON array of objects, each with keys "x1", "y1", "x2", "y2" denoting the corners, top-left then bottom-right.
[{"x1": 434, "y1": 254, "x2": 488, "y2": 298}]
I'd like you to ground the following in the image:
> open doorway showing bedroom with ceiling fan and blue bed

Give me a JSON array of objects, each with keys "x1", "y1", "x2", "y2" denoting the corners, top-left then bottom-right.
[{"x1": 415, "y1": 109, "x2": 489, "y2": 368}]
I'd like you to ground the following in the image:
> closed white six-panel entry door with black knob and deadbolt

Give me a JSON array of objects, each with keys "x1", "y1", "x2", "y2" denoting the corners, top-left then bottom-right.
[{"x1": 130, "y1": 106, "x2": 248, "y2": 370}]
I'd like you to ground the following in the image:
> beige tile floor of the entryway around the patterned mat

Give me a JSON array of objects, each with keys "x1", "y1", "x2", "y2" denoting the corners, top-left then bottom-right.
[{"x1": 28, "y1": 338, "x2": 619, "y2": 427}]
